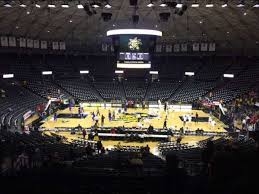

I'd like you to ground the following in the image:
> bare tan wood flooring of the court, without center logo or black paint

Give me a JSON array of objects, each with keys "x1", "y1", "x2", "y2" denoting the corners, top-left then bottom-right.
[{"x1": 41, "y1": 107, "x2": 226, "y2": 132}]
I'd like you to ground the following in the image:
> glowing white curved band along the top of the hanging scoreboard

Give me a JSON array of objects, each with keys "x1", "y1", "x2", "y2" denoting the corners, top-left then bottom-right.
[{"x1": 107, "y1": 29, "x2": 162, "y2": 36}]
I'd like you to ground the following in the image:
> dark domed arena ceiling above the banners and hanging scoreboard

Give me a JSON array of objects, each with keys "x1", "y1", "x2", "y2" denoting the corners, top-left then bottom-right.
[{"x1": 0, "y1": 0, "x2": 259, "y2": 47}]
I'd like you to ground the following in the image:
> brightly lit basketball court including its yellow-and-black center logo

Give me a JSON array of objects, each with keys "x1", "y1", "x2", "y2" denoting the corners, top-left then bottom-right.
[{"x1": 41, "y1": 107, "x2": 227, "y2": 133}]
